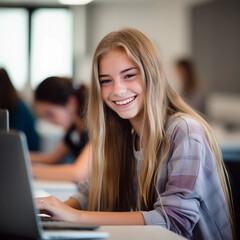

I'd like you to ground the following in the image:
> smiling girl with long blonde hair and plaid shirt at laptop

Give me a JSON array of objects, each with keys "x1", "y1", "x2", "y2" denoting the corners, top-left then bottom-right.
[{"x1": 36, "y1": 28, "x2": 232, "y2": 240}]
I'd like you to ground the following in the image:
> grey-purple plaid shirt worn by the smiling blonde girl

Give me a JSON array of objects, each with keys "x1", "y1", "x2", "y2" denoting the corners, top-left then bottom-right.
[{"x1": 72, "y1": 116, "x2": 232, "y2": 240}]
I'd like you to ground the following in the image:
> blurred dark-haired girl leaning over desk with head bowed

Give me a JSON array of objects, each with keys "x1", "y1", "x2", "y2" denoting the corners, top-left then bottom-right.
[{"x1": 30, "y1": 76, "x2": 90, "y2": 182}]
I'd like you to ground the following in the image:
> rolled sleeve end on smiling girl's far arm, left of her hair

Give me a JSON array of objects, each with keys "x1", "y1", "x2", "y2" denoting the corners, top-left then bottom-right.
[{"x1": 71, "y1": 179, "x2": 89, "y2": 211}]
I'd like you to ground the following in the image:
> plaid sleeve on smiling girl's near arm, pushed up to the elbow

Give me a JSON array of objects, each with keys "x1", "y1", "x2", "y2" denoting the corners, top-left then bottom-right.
[{"x1": 141, "y1": 137, "x2": 205, "y2": 237}]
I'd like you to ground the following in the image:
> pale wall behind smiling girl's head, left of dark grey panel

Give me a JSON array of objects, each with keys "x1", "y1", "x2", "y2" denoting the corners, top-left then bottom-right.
[{"x1": 76, "y1": 0, "x2": 214, "y2": 81}]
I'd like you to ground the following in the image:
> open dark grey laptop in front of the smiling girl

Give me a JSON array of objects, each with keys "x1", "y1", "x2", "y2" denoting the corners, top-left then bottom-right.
[{"x1": 0, "y1": 131, "x2": 109, "y2": 239}]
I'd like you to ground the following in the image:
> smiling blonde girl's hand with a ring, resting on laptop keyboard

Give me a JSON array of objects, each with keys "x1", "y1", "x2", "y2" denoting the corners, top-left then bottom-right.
[{"x1": 35, "y1": 196, "x2": 80, "y2": 222}]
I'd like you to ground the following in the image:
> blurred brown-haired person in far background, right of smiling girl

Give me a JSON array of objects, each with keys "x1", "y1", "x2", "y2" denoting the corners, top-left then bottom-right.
[{"x1": 176, "y1": 59, "x2": 206, "y2": 114}]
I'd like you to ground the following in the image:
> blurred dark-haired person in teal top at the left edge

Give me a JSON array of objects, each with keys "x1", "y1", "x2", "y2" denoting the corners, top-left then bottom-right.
[{"x1": 0, "y1": 68, "x2": 40, "y2": 151}]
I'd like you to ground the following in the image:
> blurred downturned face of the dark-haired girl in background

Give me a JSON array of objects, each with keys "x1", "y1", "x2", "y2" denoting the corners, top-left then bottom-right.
[{"x1": 35, "y1": 101, "x2": 74, "y2": 130}]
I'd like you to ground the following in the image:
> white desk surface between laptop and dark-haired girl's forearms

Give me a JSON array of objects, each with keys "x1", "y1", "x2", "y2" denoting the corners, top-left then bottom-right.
[{"x1": 33, "y1": 180, "x2": 77, "y2": 201}]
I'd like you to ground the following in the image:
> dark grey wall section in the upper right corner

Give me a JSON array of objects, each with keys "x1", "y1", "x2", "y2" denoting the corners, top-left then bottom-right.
[{"x1": 191, "y1": 0, "x2": 240, "y2": 95}]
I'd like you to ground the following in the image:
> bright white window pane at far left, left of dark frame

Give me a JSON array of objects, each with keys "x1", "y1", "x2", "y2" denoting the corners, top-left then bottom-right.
[{"x1": 0, "y1": 8, "x2": 28, "y2": 90}]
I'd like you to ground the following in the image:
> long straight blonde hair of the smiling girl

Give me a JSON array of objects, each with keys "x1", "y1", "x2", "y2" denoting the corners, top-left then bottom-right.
[{"x1": 89, "y1": 28, "x2": 231, "y2": 232}]
